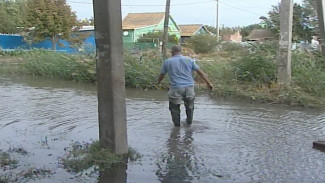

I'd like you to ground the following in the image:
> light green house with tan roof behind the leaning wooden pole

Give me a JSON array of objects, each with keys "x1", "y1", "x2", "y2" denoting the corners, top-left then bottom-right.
[{"x1": 122, "y1": 12, "x2": 180, "y2": 43}]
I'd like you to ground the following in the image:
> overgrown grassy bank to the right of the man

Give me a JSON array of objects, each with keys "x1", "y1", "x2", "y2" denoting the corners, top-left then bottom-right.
[{"x1": 196, "y1": 43, "x2": 325, "y2": 107}]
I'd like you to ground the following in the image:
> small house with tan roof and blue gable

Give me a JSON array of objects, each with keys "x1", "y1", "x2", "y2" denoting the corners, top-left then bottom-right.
[{"x1": 179, "y1": 24, "x2": 209, "y2": 43}]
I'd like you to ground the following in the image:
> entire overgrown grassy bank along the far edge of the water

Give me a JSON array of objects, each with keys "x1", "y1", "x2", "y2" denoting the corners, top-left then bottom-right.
[{"x1": 0, "y1": 43, "x2": 325, "y2": 106}]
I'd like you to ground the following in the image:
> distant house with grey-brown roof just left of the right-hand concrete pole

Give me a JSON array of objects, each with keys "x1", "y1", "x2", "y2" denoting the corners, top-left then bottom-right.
[{"x1": 245, "y1": 29, "x2": 277, "y2": 42}]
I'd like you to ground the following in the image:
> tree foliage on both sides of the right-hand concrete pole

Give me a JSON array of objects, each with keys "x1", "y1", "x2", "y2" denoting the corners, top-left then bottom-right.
[{"x1": 261, "y1": 0, "x2": 318, "y2": 41}]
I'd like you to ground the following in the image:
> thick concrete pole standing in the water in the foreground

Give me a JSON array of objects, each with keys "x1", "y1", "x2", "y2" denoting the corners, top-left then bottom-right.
[{"x1": 93, "y1": 0, "x2": 128, "y2": 154}]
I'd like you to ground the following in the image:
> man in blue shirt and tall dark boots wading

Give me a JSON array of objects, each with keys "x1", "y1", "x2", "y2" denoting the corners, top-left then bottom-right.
[{"x1": 158, "y1": 45, "x2": 213, "y2": 127}]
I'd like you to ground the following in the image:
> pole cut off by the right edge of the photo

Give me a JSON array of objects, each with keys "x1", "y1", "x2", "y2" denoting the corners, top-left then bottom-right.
[{"x1": 316, "y1": 0, "x2": 325, "y2": 56}]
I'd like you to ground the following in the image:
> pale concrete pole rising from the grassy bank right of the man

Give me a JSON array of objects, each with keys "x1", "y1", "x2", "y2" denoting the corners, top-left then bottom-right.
[{"x1": 278, "y1": 0, "x2": 293, "y2": 84}]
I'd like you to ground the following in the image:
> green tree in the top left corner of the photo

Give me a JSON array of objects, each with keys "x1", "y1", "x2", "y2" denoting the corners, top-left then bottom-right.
[{"x1": 0, "y1": 0, "x2": 26, "y2": 33}]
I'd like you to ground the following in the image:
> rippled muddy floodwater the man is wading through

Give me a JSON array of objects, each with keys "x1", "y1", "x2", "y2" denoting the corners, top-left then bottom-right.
[{"x1": 0, "y1": 77, "x2": 325, "y2": 183}]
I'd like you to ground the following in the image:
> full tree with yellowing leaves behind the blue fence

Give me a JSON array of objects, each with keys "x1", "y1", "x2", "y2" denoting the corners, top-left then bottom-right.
[{"x1": 27, "y1": 0, "x2": 78, "y2": 50}]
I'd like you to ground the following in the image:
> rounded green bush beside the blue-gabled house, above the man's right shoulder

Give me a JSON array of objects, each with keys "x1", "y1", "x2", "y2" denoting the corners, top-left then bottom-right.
[{"x1": 187, "y1": 34, "x2": 218, "y2": 53}]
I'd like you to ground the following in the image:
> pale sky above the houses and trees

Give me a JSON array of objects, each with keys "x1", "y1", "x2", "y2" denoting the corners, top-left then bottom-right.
[{"x1": 67, "y1": 0, "x2": 302, "y2": 27}]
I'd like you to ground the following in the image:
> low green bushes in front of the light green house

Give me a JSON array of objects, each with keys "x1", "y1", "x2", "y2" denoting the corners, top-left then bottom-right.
[{"x1": 138, "y1": 32, "x2": 178, "y2": 44}]
